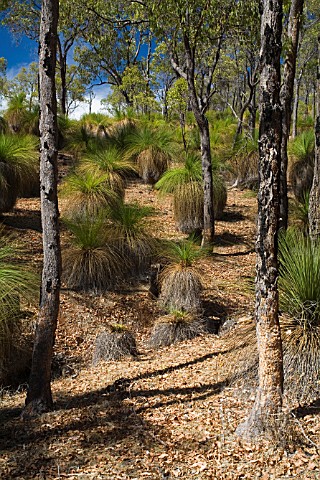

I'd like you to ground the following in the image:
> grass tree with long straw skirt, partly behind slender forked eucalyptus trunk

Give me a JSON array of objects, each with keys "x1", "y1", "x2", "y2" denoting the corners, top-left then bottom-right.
[{"x1": 155, "y1": 153, "x2": 227, "y2": 233}]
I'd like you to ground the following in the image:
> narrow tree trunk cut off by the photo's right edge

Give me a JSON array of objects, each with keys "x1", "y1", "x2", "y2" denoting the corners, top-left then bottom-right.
[{"x1": 309, "y1": 36, "x2": 320, "y2": 241}]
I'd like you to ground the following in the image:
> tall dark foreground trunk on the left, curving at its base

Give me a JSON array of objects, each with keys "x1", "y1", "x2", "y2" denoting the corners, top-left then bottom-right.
[{"x1": 23, "y1": 0, "x2": 61, "y2": 417}]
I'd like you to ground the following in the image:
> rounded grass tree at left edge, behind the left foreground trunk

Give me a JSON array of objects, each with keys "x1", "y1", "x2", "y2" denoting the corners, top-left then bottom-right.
[{"x1": 0, "y1": 134, "x2": 39, "y2": 213}]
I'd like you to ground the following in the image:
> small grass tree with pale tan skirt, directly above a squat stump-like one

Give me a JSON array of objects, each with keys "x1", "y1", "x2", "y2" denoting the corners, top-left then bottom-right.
[{"x1": 159, "y1": 240, "x2": 204, "y2": 312}]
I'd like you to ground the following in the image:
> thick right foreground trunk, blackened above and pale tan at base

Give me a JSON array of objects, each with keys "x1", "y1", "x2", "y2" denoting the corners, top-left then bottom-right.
[{"x1": 237, "y1": 0, "x2": 283, "y2": 439}]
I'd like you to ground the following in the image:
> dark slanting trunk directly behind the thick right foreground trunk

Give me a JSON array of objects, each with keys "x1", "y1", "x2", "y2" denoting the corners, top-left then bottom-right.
[{"x1": 279, "y1": 0, "x2": 304, "y2": 229}]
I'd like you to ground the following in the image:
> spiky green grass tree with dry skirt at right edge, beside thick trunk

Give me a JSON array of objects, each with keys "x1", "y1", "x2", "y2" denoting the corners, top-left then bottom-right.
[{"x1": 279, "y1": 229, "x2": 320, "y2": 402}]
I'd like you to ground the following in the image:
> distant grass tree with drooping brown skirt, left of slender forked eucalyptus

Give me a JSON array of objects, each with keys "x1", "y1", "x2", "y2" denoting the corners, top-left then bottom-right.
[{"x1": 126, "y1": 125, "x2": 177, "y2": 184}]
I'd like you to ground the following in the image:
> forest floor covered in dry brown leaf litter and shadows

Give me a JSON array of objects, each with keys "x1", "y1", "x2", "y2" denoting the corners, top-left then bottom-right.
[{"x1": 0, "y1": 182, "x2": 320, "y2": 480}]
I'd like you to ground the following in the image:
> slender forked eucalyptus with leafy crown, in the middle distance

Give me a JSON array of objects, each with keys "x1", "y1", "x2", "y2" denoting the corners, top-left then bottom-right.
[{"x1": 138, "y1": 0, "x2": 242, "y2": 244}]
